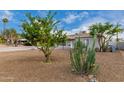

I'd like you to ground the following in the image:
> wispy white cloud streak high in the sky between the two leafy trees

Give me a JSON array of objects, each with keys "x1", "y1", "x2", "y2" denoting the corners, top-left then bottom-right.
[{"x1": 63, "y1": 12, "x2": 88, "y2": 24}]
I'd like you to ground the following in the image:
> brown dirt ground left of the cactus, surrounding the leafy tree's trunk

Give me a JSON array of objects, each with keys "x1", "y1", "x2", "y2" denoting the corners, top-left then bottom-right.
[{"x1": 0, "y1": 50, "x2": 85, "y2": 82}]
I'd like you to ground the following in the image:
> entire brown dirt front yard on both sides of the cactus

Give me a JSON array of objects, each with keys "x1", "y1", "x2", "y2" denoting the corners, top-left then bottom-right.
[{"x1": 0, "y1": 50, "x2": 124, "y2": 82}]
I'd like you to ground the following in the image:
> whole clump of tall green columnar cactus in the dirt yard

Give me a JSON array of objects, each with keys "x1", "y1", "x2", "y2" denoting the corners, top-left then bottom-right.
[{"x1": 70, "y1": 30, "x2": 98, "y2": 75}]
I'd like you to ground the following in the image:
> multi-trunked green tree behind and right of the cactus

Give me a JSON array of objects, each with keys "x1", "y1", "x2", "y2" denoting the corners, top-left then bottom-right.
[{"x1": 89, "y1": 22, "x2": 121, "y2": 52}]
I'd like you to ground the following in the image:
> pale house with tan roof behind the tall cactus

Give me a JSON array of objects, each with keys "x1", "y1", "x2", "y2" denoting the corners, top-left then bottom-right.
[{"x1": 66, "y1": 31, "x2": 99, "y2": 48}]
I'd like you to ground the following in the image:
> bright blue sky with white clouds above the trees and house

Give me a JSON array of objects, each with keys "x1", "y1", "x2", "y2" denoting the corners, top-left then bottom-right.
[{"x1": 0, "y1": 10, "x2": 124, "y2": 37}]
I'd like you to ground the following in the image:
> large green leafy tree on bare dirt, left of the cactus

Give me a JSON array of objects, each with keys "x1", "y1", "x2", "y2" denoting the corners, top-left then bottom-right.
[{"x1": 22, "y1": 12, "x2": 66, "y2": 62}]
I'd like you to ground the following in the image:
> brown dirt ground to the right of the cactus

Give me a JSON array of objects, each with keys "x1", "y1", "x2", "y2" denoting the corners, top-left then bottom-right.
[{"x1": 96, "y1": 52, "x2": 124, "y2": 82}]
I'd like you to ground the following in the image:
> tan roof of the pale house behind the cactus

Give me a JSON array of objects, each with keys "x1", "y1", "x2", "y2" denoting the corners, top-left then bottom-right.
[{"x1": 68, "y1": 31, "x2": 92, "y2": 40}]
